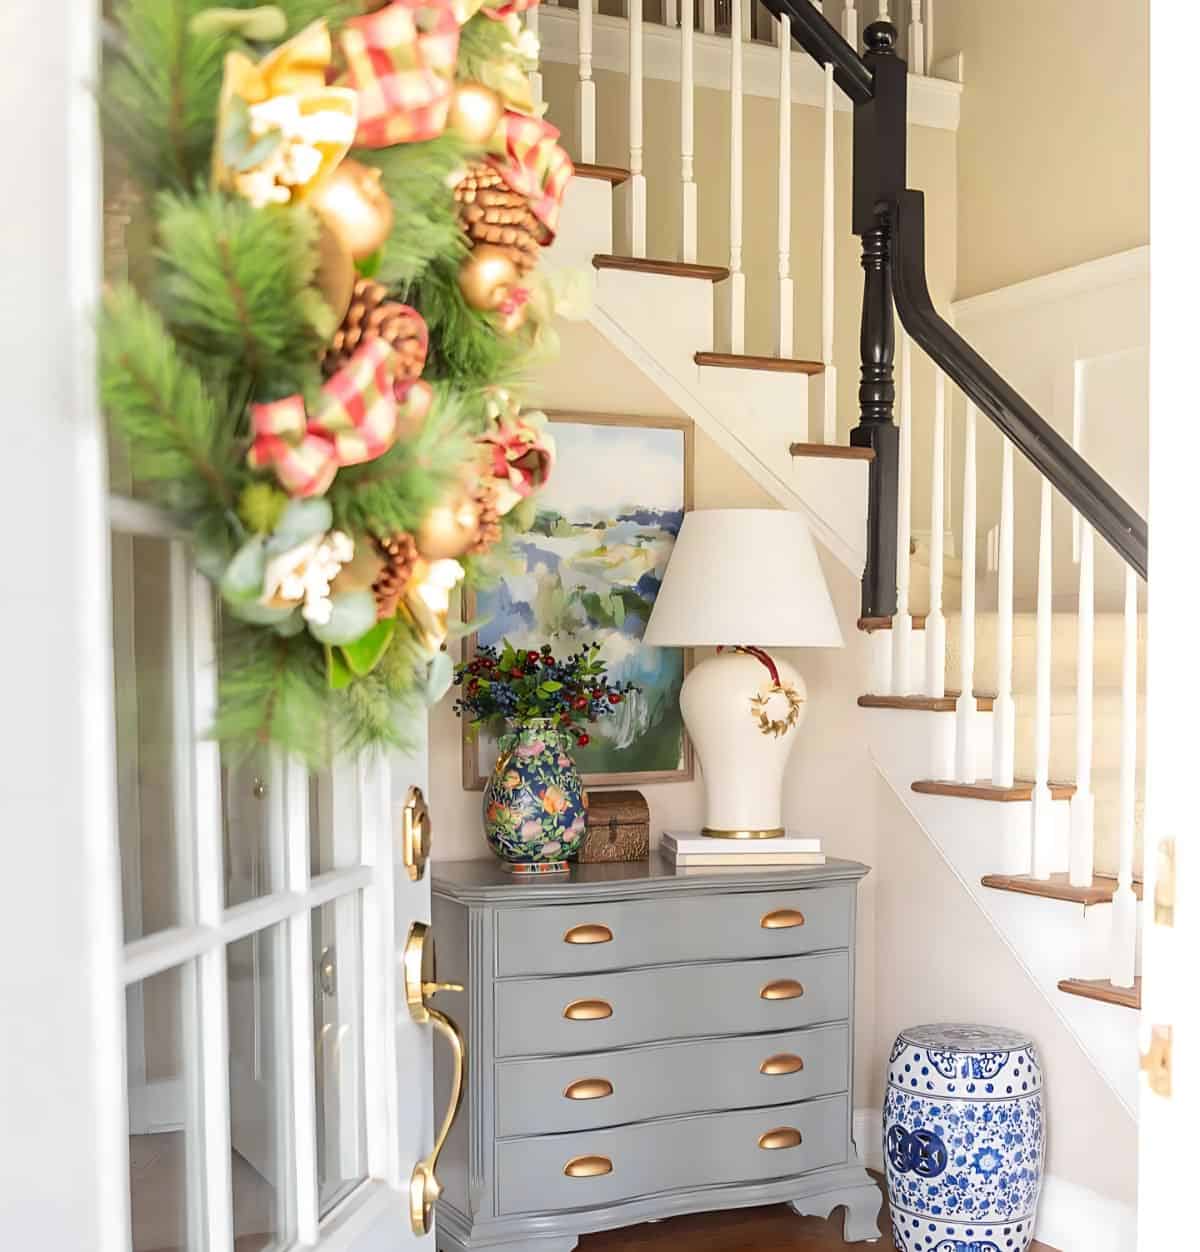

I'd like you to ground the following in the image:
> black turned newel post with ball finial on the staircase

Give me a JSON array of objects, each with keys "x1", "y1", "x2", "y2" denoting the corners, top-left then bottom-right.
[{"x1": 851, "y1": 14, "x2": 908, "y2": 617}]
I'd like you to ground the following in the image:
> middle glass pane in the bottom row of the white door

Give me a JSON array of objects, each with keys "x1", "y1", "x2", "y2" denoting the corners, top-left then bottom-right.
[{"x1": 227, "y1": 925, "x2": 296, "y2": 1252}]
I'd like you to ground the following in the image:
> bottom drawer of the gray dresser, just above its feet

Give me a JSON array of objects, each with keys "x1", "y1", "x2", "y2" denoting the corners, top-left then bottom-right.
[{"x1": 496, "y1": 1096, "x2": 849, "y2": 1214}]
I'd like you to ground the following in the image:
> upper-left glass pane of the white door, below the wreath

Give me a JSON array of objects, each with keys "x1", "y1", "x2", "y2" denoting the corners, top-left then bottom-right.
[{"x1": 111, "y1": 535, "x2": 192, "y2": 940}]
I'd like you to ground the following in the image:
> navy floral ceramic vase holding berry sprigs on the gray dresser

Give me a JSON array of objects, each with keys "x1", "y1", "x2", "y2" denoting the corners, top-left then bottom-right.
[{"x1": 484, "y1": 721, "x2": 587, "y2": 874}]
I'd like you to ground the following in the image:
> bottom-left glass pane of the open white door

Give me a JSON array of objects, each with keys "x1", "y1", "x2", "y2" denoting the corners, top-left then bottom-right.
[{"x1": 125, "y1": 964, "x2": 204, "y2": 1252}]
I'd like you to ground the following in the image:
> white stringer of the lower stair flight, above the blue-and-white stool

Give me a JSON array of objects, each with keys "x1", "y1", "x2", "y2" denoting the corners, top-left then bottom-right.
[{"x1": 863, "y1": 709, "x2": 1139, "y2": 1121}]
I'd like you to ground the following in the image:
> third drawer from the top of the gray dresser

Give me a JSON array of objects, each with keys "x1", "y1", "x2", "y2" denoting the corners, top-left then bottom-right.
[{"x1": 496, "y1": 1024, "x2": 849, "y2": 1138}]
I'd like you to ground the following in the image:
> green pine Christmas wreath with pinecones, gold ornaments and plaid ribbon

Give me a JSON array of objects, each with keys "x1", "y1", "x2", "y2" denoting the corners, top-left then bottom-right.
[{"x1": 100, "y1": 0, "x2": 572, "y2": 765}]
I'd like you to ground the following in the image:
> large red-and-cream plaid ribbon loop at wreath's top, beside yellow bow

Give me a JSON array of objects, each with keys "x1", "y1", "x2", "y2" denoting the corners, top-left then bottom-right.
[{"x1": 341, "y1": 0, "x2": 468, "y2": 148}]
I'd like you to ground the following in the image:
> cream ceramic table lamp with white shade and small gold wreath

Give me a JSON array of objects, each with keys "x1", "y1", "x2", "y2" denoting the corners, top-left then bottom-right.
[{"x1": 645, "y1": 508, "x2": 843, "y2": 839}]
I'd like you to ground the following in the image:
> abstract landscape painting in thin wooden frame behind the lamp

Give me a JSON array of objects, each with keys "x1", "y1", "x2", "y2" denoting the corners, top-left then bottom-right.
[{"x1": 462, "y1": 413, "x2": 694, "y2": 791}]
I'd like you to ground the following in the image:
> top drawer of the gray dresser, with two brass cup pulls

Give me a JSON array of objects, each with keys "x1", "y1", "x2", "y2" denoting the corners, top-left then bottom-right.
[{"x1": 496, "y1": 883, "x2": 854, "y2": 978}]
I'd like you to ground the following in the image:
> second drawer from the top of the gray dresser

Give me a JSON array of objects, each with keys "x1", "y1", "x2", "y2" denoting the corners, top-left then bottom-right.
[{"x1": 495, "y1": 952, "x2": 851, "y2": 1057}]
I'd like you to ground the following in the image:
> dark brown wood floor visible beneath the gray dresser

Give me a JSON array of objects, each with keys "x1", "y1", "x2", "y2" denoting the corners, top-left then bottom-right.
[{"x1": 579, "y1": 1176, "x2": 1055, "y2": 1252}]
